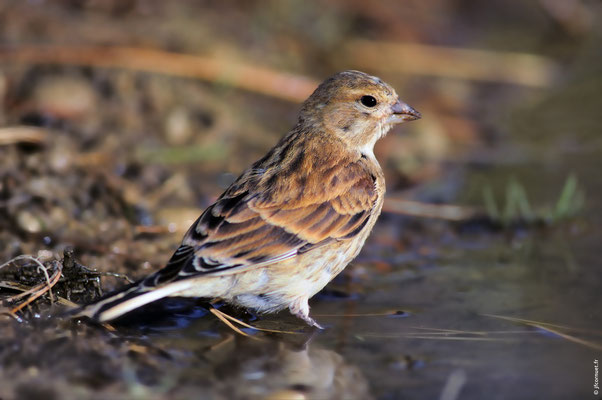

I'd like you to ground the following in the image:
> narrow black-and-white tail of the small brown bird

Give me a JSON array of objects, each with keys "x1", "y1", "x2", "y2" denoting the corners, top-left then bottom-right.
[{"x1": 69, "y1": 280, "x2": 196, "y2": 322}]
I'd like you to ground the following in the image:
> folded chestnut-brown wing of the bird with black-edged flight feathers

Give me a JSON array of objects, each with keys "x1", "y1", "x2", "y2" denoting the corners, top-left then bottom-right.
[{"x1": 144, "y1": 162, "x2": 378, "y2": 286}]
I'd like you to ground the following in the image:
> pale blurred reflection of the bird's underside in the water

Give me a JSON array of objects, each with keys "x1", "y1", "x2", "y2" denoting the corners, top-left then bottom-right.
[{"x1": 198, "y1": 335, "x2": 372, "y2": 399}]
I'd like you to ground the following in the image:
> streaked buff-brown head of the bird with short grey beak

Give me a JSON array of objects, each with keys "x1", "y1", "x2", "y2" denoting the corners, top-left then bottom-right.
[{"x1": 300, "y1": 71, "x2": 421, "y2": 153}]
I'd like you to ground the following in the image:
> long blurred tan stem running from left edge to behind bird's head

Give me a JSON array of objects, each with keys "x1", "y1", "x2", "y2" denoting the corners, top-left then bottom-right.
[{"x1": 0, "y1": 45, "x2": 318, "y2": 102}]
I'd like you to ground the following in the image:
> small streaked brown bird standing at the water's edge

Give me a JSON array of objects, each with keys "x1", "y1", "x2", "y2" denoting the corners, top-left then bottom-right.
[{"x1": 78, "y1": 71, "x2": 420, "y2": 328}]
